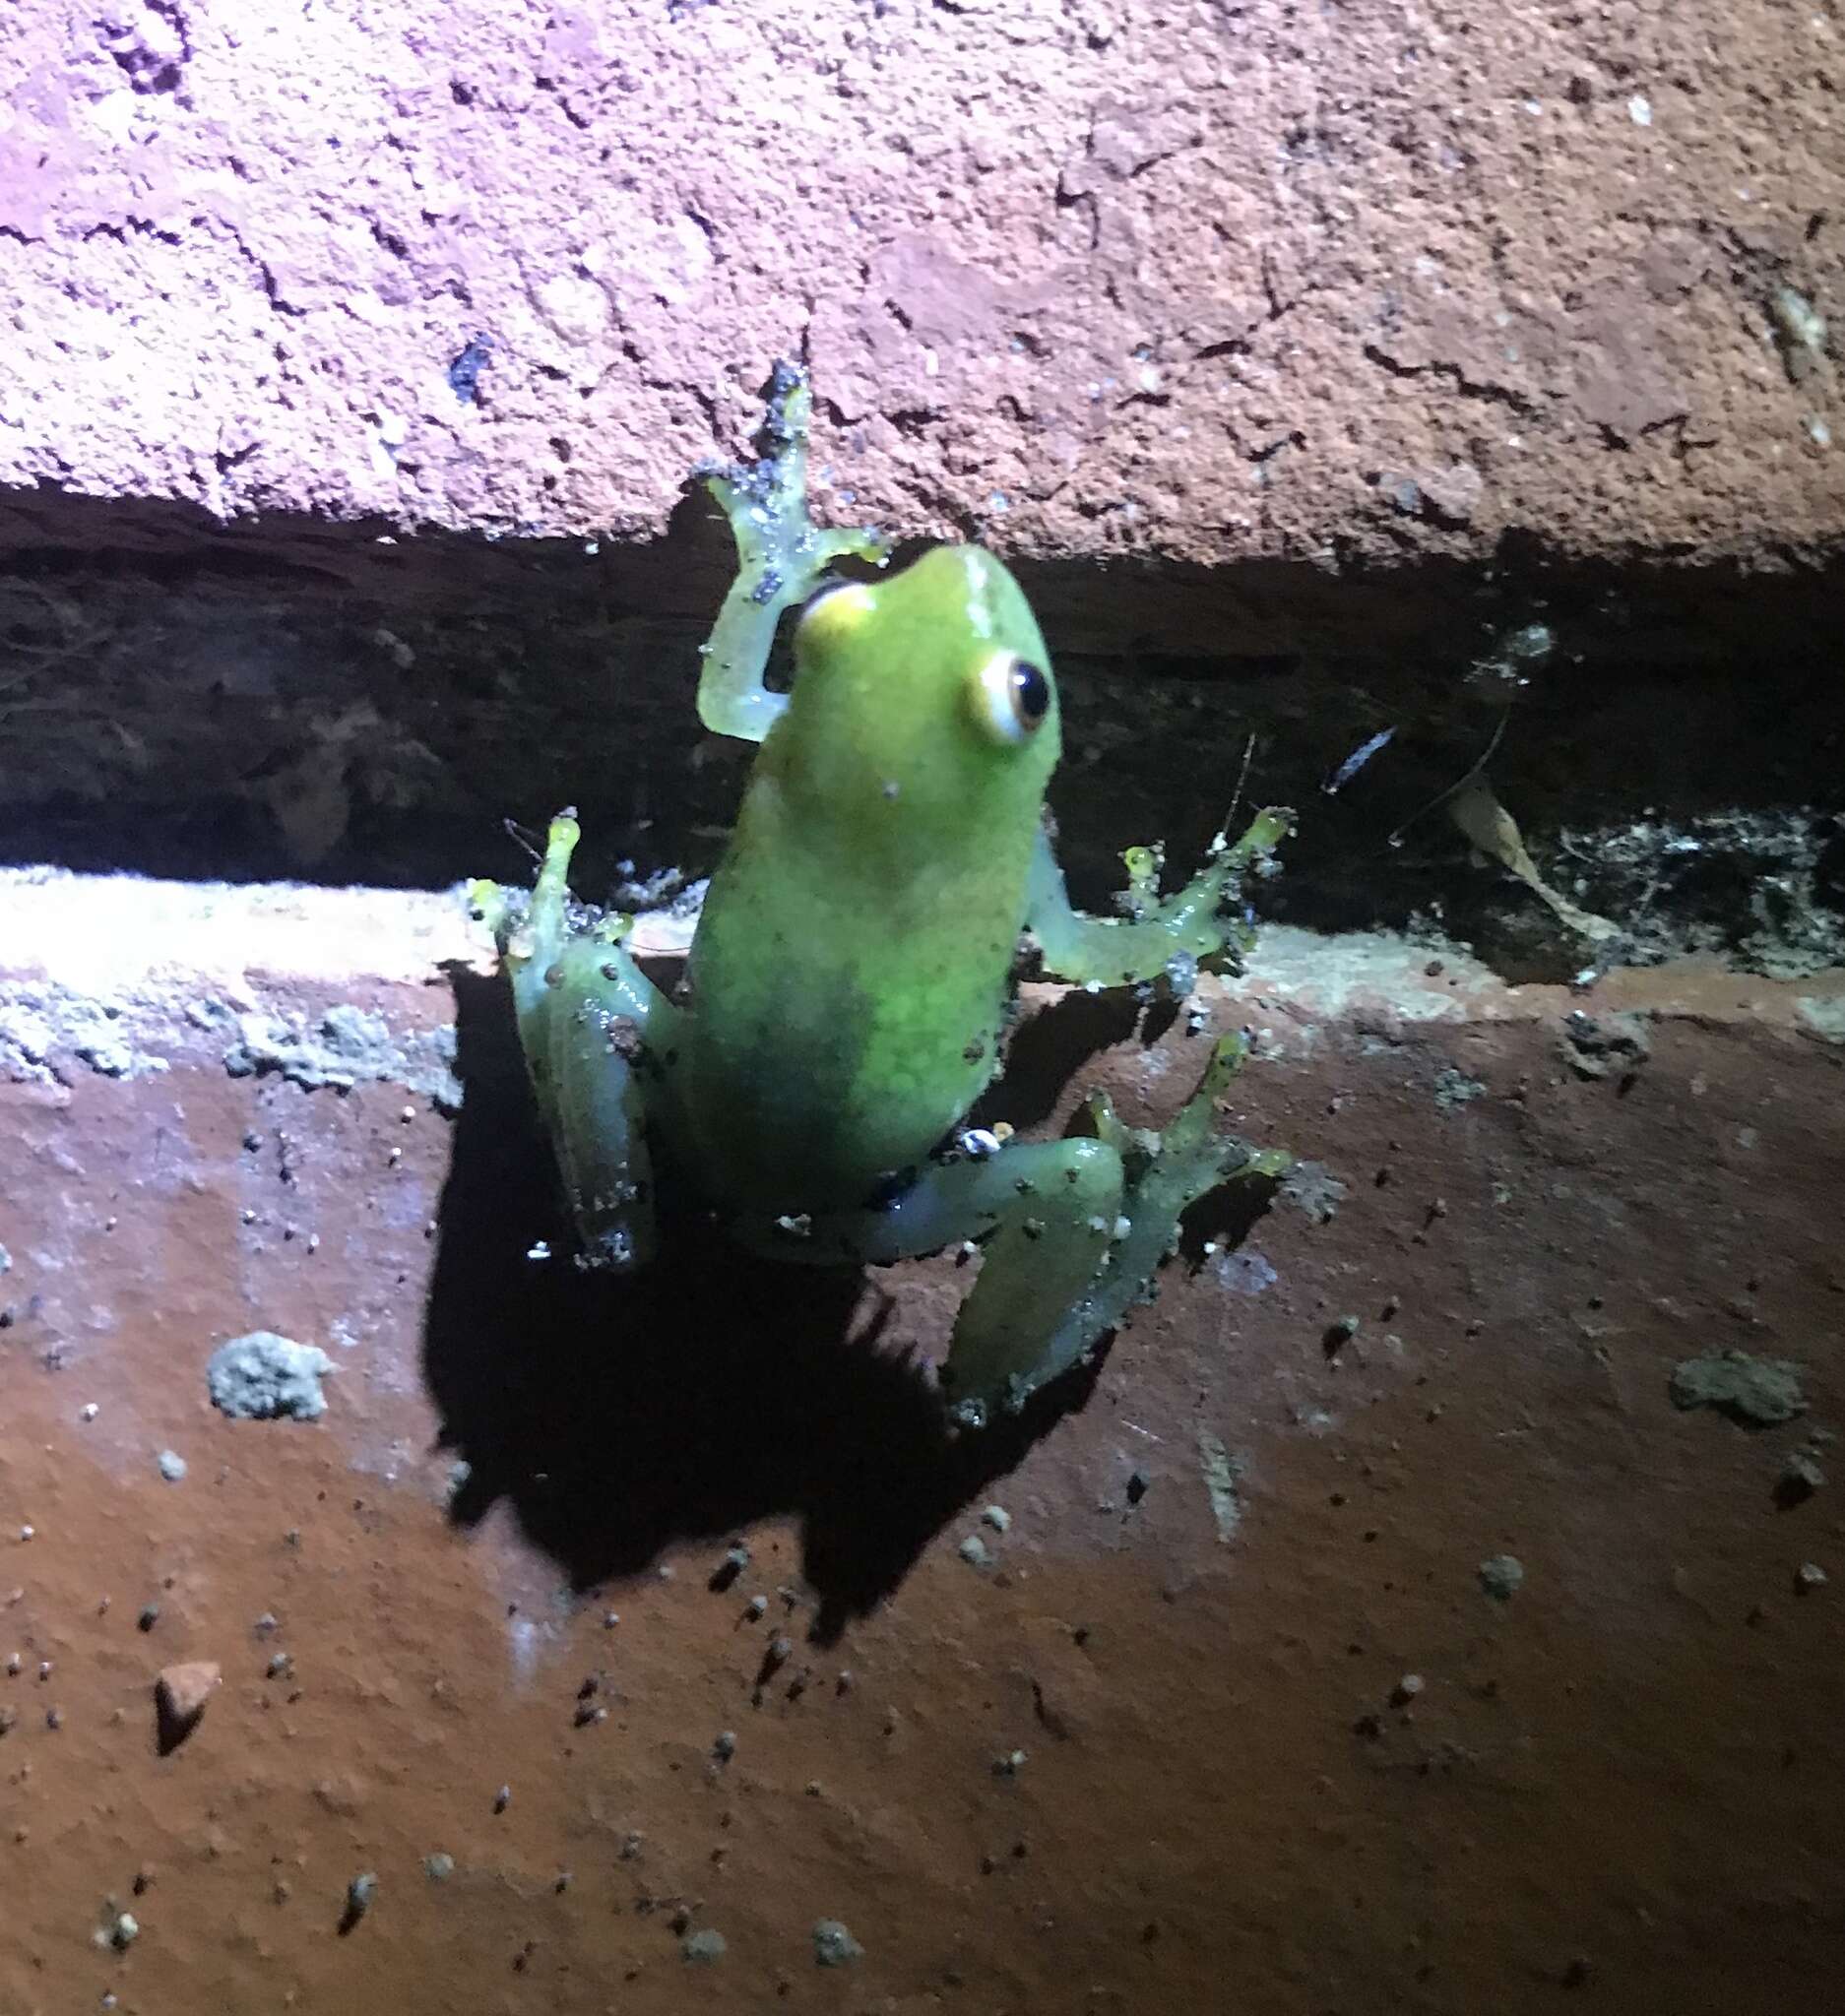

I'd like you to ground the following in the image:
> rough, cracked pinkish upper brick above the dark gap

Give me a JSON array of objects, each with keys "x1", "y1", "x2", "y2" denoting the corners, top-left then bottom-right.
[{"x1": 0, "y1": 0, "x2": 1845, "y2": 560}]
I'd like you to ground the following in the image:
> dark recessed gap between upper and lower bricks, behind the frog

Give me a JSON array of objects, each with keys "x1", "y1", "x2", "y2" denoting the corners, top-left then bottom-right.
[{"x1": 0, "y1": 494, "x2": 1845, "y2": 976}]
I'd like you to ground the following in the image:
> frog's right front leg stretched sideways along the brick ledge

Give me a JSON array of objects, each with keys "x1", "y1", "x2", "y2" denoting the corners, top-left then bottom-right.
[{"x1": 1024, "y1": 806, "x2": 1293, "y2": 998}]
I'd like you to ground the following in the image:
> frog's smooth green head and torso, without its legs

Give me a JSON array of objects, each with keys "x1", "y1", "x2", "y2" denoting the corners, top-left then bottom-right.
[{"x1": 673, "y1": 548, "x2": 1056, "y2": 1214}]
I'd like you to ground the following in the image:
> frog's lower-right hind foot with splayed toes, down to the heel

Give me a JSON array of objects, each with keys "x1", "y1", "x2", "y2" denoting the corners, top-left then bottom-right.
[{"x1": 941, "y1": 1037, "x2": 1291, "y2": 1425}]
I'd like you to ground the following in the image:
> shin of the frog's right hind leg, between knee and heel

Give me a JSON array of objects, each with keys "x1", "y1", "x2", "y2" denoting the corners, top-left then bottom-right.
[{"x1": 895, "y1": 1139, "x2": 1123, "y2": 1416}]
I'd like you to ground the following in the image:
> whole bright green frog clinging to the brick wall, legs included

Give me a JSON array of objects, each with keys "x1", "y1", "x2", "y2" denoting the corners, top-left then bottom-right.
[{"x1": 472, "y1": 365, "x2": 1291, "y2": 1427}]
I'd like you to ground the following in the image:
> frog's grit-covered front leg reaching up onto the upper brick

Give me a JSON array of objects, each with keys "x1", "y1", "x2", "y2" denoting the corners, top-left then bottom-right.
[{"x1": 696, "y1": 361, "x2": 891, "y2": 742}]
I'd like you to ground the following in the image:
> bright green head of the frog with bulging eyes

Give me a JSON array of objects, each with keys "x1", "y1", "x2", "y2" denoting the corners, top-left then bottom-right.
[{"x1": 774, "y1": 546, "x2": 1058, "y2": 847}]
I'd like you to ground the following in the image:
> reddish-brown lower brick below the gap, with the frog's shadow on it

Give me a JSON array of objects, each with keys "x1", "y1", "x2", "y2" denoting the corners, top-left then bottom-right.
[{"x1": 0, "y1": 883, "x2": 1845, "y2": 2016}]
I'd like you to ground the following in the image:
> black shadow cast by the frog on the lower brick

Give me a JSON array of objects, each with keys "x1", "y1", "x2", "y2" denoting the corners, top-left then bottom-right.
[{"x1": 423, "y1": 970, "x2": 1137, "y2": 1643}]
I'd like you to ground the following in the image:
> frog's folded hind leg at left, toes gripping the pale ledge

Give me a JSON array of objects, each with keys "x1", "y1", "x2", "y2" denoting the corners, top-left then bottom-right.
[{"x1": 470, "y1": 812, "x2": 677, "y2": 1270}]
